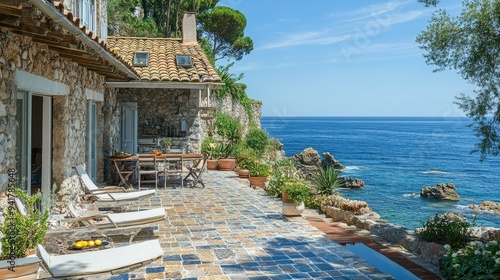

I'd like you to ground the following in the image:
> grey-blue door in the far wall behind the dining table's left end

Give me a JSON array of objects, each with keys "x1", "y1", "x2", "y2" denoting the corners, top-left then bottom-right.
[{"x1": 120, "y1": 102, "x2": 137, "y2": 155}]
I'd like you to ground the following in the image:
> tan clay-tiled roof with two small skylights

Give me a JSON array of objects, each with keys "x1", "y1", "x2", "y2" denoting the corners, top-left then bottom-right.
[{"x1": 107, "y1": 37, "x2": 222, "y2": 83}]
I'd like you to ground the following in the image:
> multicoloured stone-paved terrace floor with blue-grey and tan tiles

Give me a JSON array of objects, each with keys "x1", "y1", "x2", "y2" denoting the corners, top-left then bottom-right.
[{"x1": 40, "y1": 171, "x2": 392, "y2": 280}]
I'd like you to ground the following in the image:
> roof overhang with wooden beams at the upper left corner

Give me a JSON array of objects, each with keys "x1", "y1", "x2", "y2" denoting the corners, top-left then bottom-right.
[{"x1": 0, "y1": 0, "x2": 137, "y2": 80}]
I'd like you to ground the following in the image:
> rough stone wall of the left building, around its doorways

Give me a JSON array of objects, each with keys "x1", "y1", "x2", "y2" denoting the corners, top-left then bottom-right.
[{"x1": 0, "y1": 28, "x2": 110, "y2": 212}]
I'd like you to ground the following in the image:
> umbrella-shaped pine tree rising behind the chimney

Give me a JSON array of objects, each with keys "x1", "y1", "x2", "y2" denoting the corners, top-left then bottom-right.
[{"x1": 199, "y1": 6, "x2": 253, "y2": 61}]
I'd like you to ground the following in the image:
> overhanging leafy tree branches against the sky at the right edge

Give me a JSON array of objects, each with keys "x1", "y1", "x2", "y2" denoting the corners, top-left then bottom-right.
[{"x1": 417, "y1": 0, "x2": 500, "y2": 161}]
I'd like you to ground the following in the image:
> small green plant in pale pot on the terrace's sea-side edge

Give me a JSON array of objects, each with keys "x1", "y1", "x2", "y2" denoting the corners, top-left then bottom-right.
[{"x1": 281, "y1": 181, "x2": 311, "y2": 216}]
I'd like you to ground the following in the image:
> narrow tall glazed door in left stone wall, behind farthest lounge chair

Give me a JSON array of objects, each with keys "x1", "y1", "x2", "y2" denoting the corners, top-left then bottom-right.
[{"x1": 86, "y1": 101, "x2": 97, "y2": 182}]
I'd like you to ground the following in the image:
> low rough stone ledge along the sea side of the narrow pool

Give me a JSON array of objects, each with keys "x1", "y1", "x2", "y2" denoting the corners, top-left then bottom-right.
[{"x1": 323, "y1": 206, "x2": 444, "y2": 265}]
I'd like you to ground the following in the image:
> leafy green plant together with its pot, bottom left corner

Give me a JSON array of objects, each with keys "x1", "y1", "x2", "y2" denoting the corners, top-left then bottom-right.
[{"x1": 0, "y1": 187, "x2": 49, "y2": 279}]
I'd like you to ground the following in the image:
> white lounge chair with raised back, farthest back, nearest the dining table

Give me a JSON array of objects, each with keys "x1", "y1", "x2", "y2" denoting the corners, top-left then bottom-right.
[{"x1": 76, "y1": 164, "x2": 156, "y2": 203}]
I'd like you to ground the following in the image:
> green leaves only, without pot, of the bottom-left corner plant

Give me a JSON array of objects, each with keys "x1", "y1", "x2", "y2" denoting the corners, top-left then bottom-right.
[{"x1": 0, "y1": 188, "x2": 49, "y2": 259}]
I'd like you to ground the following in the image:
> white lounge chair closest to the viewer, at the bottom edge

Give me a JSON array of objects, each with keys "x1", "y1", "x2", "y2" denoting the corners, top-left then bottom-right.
[{"x1": 38, "y1": 239, "x2": 163, "y2": 279}]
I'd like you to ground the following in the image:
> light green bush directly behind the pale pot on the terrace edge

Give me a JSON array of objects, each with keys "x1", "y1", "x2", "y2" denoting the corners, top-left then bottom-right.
[{"x1": 265, "y1": 159, "x2": 302, "y2": 196}]
